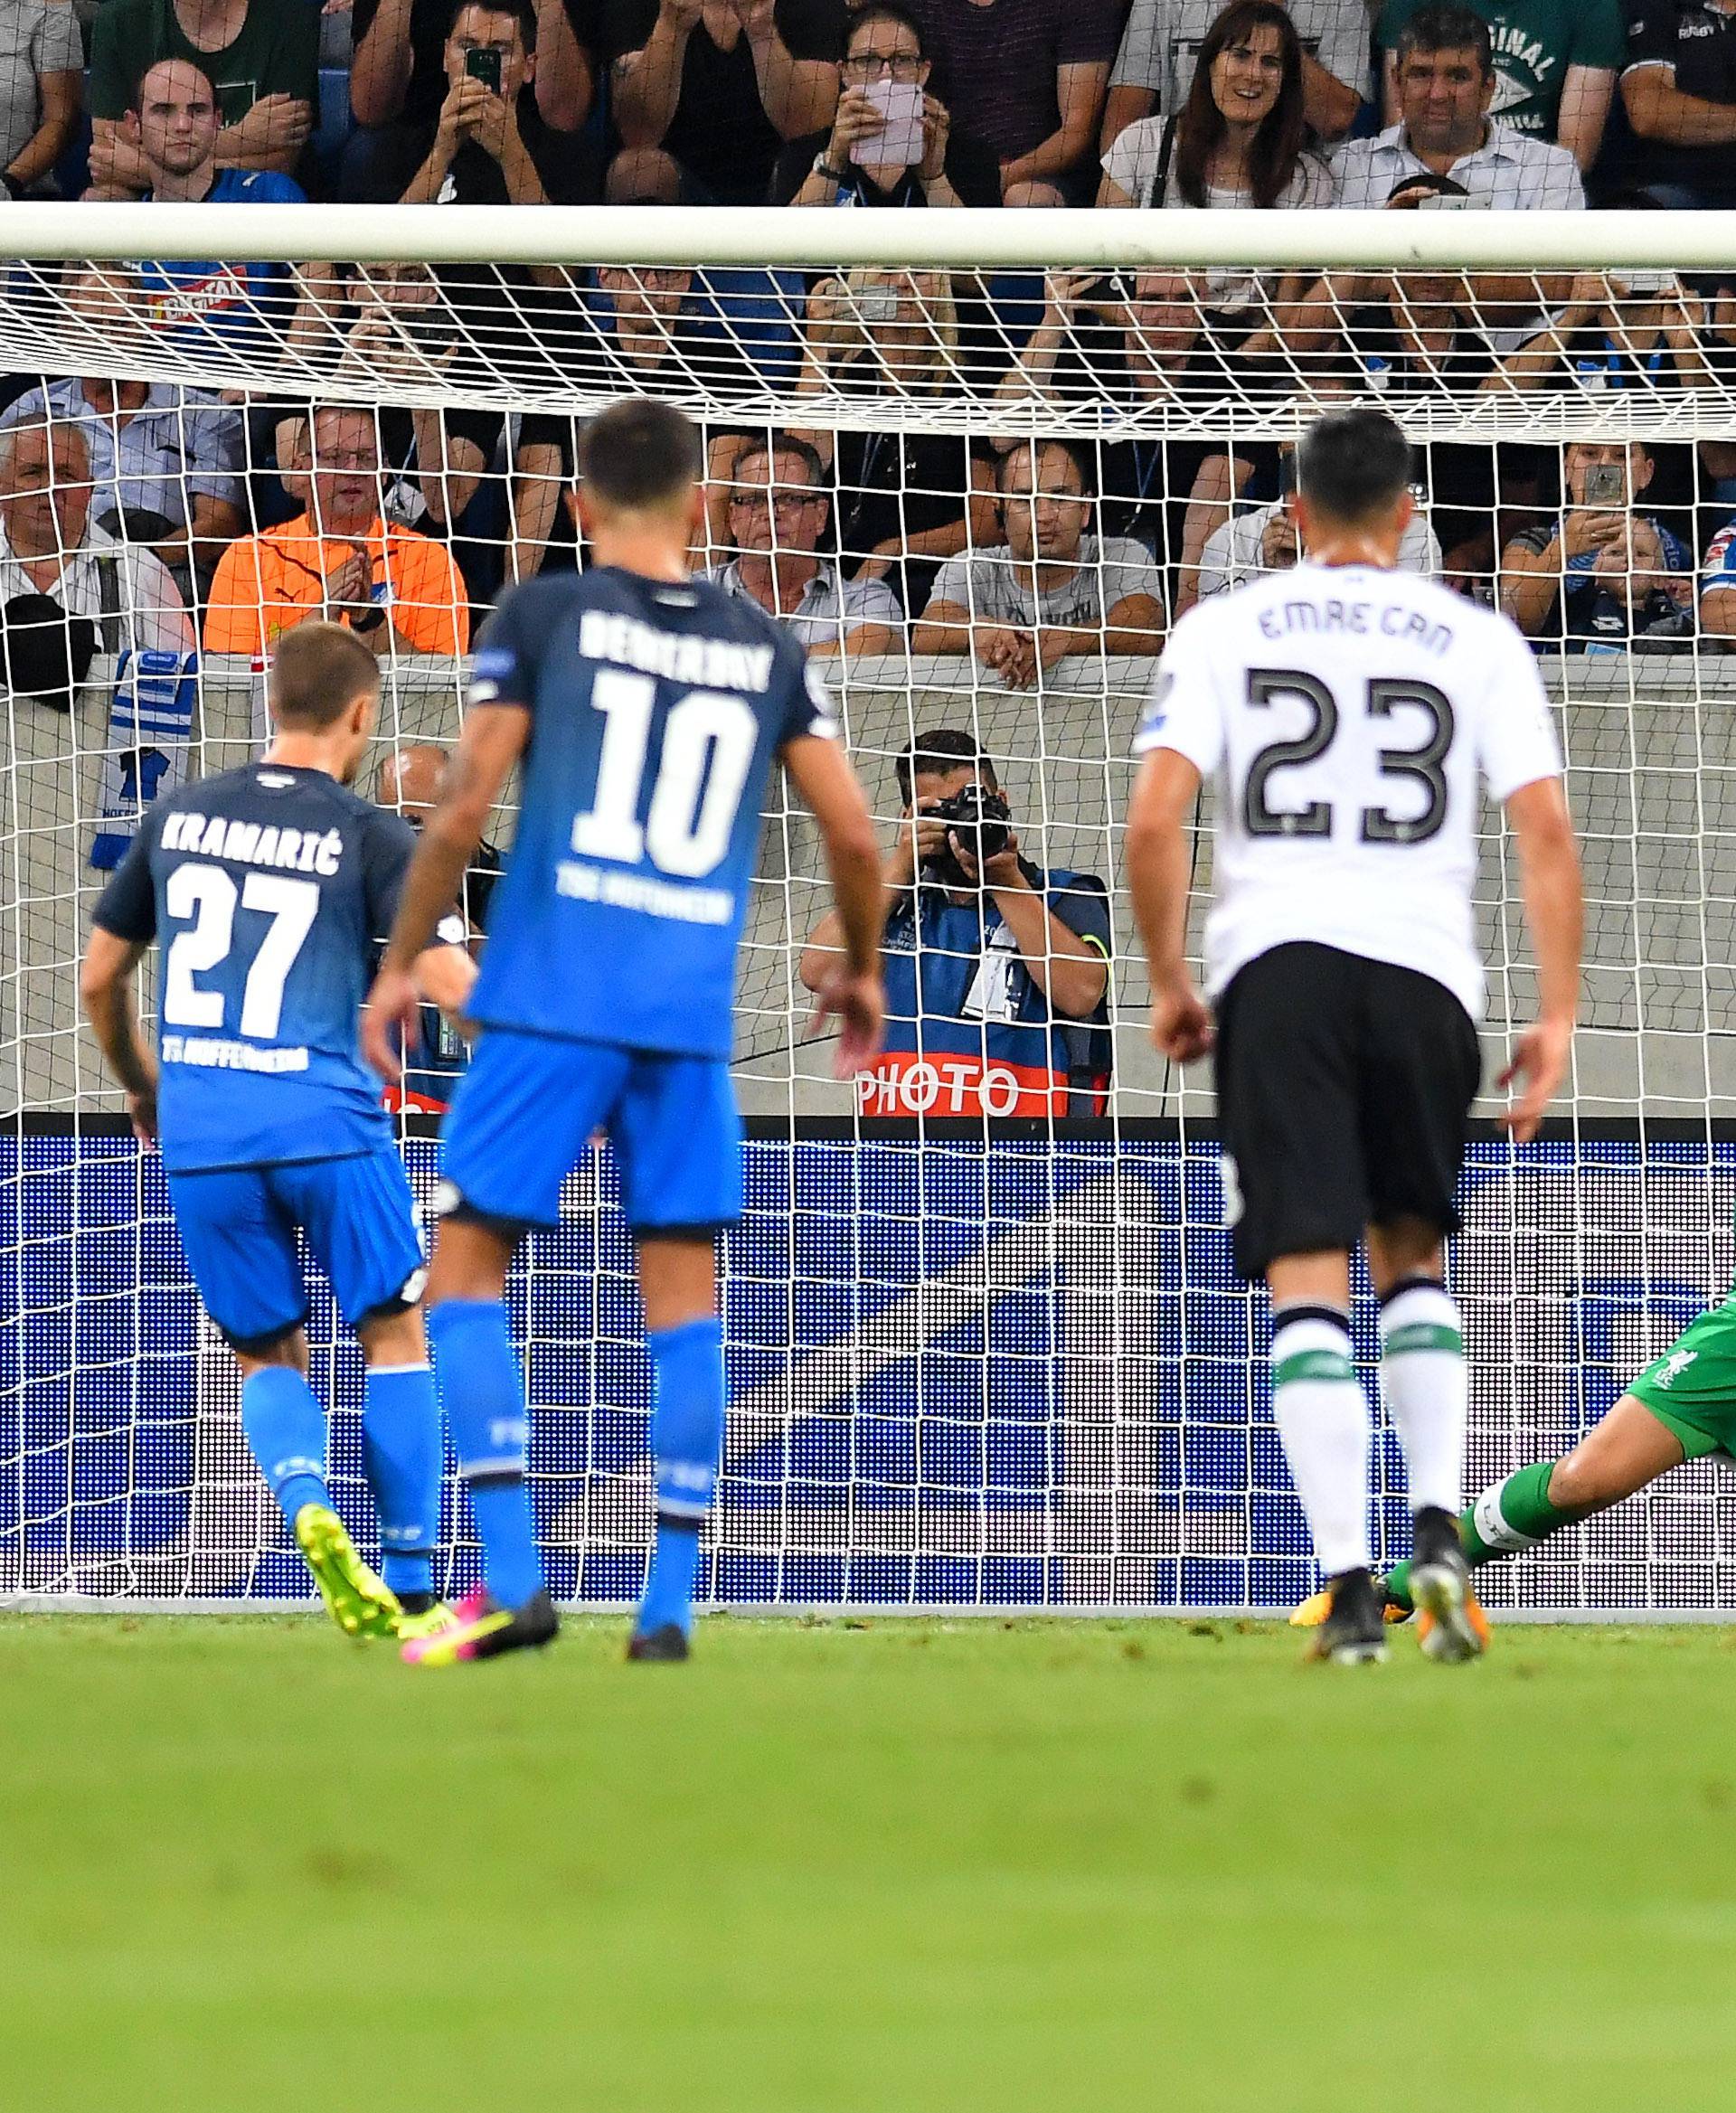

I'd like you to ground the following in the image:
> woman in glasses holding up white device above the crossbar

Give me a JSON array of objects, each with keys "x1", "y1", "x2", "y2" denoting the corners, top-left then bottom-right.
[{"x1": 771, "y1": 0, "x2": 1001, "y2": 205}]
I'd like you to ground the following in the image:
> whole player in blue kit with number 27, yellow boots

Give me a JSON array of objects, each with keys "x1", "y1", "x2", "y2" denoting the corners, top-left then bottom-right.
[{"x1": 82, "y1": 623, "x2": 473, "y2": 1636}]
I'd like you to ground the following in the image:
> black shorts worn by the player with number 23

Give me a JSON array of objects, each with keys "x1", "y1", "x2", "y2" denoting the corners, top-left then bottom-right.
[{"x1": 1216, "y1": 945, "x2": 1483, "y2": 1278}]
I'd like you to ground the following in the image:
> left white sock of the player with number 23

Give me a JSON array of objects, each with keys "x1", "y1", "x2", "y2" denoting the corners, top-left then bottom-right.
[{"x1": 1271, "y1": 1306, "x2": 1373, "y2": 1579}]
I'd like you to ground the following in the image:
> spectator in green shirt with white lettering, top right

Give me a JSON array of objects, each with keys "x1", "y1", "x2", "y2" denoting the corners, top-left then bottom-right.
[{"x1": 1375, "y1": 0, "x2": 1628, "y2": 174}]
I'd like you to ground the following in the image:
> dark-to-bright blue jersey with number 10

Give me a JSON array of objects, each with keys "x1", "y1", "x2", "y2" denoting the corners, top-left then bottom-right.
[{"x1": 467, "y1": 566, "x2": 836, "y2": 1057}]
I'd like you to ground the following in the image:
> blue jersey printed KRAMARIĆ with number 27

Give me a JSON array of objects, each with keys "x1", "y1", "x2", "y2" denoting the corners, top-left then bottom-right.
[{"x1": 95, "y1": 763, "x2": 416, "y2": 1173}]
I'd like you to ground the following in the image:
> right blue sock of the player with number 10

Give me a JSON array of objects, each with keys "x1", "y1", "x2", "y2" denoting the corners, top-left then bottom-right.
[{"x1": 636, "y1": 1315, "x2": 724, "y2": 1636}]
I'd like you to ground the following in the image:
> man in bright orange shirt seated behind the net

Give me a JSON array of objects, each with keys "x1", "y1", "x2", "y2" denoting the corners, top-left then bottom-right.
[{"x1": 205, "y1": 403, "x2": 471, "y2": 657}]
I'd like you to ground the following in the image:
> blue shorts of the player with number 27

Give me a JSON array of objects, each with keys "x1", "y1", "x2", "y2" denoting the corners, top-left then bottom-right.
[{"x1": 169, "y1": 1146, "x2": 422, "y2": 1350}]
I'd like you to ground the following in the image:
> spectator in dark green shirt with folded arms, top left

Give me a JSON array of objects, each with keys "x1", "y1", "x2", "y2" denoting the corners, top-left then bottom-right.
[{"x1": 90, "y1": 0, "x2": 319, "y2": 199}]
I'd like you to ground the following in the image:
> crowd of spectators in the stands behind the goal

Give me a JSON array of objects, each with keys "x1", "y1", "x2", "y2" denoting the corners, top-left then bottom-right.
[{"x1": 0, "y1": 0, "x2": 1736, "y2": 695}]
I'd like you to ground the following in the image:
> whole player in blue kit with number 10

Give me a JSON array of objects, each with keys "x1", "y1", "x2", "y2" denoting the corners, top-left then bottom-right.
[{"x1": 363, "y1": 400, "x2": 882, "y2": 1665}]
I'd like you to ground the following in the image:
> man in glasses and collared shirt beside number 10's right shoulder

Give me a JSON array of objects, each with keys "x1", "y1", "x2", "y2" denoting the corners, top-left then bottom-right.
[{"x1": 705, "y1": 433, "x2": 904, "y2": 659}]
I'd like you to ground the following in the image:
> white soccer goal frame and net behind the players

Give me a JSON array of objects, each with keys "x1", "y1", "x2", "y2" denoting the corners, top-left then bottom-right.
[{"x1": 0, "y1": 201, "x2": 1736, "y2": 1614}]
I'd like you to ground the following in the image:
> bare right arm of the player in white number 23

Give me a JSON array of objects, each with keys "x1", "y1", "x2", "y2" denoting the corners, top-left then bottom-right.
[{"x1": 1499, "y1": 778, "x2": 1586, "y2": 1146}]
